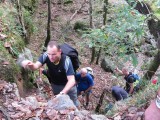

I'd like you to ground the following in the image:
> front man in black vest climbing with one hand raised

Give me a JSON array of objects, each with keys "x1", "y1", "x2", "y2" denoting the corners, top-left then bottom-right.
[{"x1": 24, "y1": 41, "x2": 78, "y2": 106}]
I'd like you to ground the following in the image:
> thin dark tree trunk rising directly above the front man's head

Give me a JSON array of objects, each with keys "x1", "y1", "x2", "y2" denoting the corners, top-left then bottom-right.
[{"x1": 44, "y1": 0, "x2": 51, "y2": 47}]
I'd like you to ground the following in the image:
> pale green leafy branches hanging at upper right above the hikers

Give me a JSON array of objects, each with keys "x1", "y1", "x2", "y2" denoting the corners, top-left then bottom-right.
[{"x1": 83, "y1": 5, "x2": 145, "y2": 65}]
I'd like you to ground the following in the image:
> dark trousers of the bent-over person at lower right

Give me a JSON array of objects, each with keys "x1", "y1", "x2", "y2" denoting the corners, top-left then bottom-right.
[{"x1": 112, "y1": 86, "x2": 128, "y2": 101}]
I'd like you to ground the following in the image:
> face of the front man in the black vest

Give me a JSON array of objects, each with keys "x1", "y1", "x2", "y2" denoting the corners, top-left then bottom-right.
[{"x1": 47, "y1": 46, "x2": 61, "y2": 63}]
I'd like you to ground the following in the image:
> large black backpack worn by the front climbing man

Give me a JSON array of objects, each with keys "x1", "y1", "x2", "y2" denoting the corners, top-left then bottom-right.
[{"x1": 60, "y1": 43, "x2": 80, "y2": 72}]
